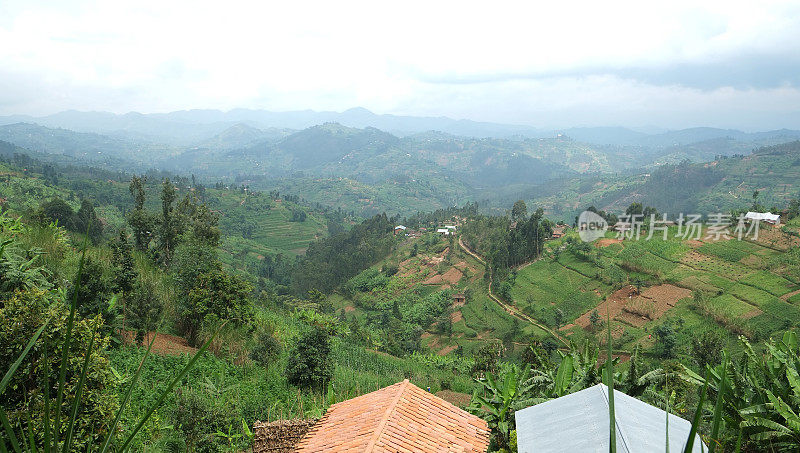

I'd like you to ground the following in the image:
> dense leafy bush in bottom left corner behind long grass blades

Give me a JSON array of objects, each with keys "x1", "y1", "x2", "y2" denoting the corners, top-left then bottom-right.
[{"x1": 0, "y1": 289, "x2": 119, "y2": 451}]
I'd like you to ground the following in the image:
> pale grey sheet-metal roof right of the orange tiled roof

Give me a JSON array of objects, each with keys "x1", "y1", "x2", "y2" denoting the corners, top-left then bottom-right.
[{"x1": 515, "y1": 384, "x2": 707, "y2": 453}]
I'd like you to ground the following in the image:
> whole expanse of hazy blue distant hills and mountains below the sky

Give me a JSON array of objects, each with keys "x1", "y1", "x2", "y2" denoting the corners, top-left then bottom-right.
[{"x1": 0, "y1": 109, "x2": 800, "y2": 216}]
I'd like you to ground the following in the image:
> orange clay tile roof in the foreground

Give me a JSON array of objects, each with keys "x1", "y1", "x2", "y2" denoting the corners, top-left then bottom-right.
[{"x1": 296, "y1": 379, "x2": 489, "y2": 453}]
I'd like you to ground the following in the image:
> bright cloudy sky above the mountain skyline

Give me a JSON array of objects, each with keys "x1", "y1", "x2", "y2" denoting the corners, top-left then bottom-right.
[{"x1": 0, "y1": 0, "x2": 800, "y2": 130}]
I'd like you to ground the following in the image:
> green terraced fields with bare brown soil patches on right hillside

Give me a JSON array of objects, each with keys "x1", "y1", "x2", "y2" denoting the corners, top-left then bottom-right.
[{"x1": 510, "y1": 228, "x2": 800, "y2": 348}]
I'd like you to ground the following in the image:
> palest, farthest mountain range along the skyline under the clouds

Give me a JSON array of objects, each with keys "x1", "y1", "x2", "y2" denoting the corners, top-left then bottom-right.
[{"x1": 0, "y1": 108, "x2": 800, "y2": 146}]
